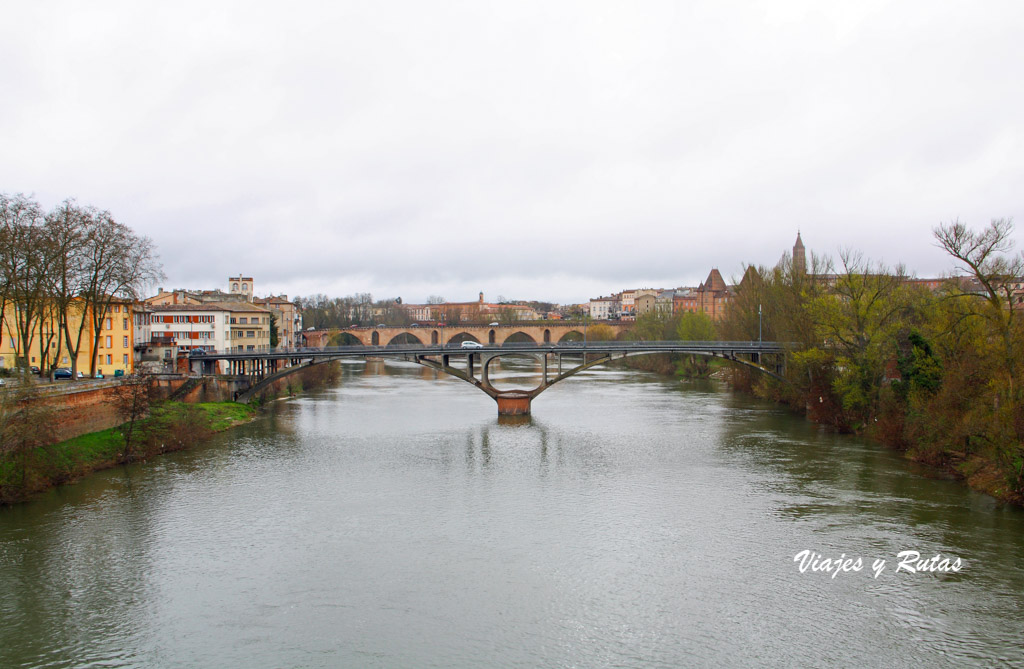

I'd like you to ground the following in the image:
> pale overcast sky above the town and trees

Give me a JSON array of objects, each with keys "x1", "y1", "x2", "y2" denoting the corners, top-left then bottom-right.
[{"x1": 0, "y1": 0, "x2": 1024, "y2": 302}]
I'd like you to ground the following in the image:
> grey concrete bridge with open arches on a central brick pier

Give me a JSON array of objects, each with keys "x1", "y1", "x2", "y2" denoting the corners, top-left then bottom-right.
[{"x1": 189, "y1": 341, "x2": 787, "y2": 415}]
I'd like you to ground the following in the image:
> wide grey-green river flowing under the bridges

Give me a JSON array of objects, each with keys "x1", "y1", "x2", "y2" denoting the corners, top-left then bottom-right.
[{"x1": 0, "y1": 362, "x2": 1024, "y2": 667}]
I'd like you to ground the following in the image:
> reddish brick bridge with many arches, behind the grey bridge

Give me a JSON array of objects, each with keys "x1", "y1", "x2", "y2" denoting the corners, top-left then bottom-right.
[{"x1": 303, "y1": 321, "x2": 632, "y2": 348}]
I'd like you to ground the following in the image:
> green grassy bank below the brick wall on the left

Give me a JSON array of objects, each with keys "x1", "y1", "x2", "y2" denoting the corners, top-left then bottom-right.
[{"x1": 0, "y1": 402, "x2": 256, "y2": 503}]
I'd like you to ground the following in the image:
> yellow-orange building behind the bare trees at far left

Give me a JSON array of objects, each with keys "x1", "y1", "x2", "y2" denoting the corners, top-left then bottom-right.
[{"x1": 0, "y1": 300, "x2": 134, "y2": 376}]
